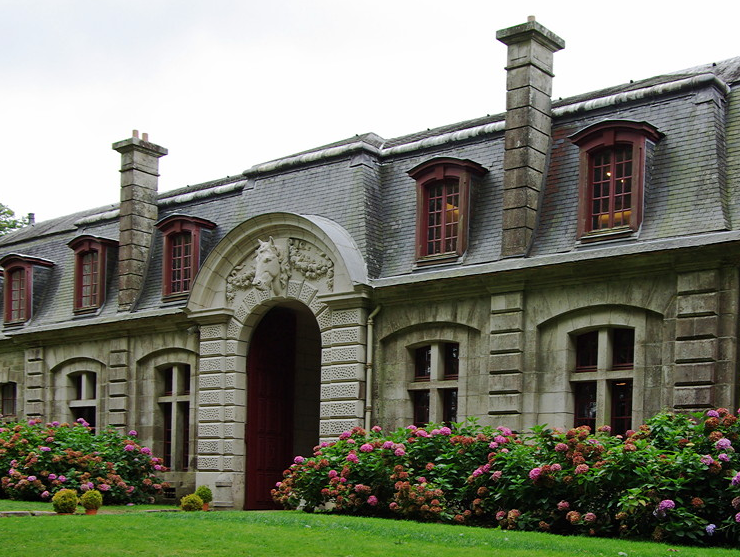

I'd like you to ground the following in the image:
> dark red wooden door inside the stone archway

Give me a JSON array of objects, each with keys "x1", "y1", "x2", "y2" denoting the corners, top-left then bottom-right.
[{"x1": 244, "y1": 308, "x2": 296, "y2": 509}]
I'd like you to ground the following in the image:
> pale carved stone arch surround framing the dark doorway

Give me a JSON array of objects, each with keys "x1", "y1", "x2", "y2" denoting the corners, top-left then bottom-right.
[{"x1": 187, "y1": 213, "x2": 370, "y2": 508}]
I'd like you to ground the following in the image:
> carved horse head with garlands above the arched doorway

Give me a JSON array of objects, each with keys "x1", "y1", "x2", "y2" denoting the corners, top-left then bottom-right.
[{"x1": 226, "y1": 236, "x2": 334, "y2": 303}]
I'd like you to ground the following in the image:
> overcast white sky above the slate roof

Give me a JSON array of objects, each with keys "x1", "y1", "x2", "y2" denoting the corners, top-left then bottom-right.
[{"x1": 0, "y1": 0, "x2": 740, "y2": 221}]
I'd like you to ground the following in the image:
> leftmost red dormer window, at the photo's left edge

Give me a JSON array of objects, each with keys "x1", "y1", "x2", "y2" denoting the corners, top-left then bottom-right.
[{"x1": 0, "y1": 254, "x2": 54, "y2": 325}]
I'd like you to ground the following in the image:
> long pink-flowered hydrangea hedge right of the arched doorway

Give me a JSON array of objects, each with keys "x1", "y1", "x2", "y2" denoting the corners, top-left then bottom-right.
[{"x1": 273, "y1": 408, "x2": 740, "y2": 544}]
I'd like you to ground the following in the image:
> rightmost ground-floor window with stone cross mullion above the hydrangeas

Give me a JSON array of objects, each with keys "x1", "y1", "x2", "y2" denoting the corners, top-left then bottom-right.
[{"x1": 571, "y1": 327, "x2": 635, "y2": 435}]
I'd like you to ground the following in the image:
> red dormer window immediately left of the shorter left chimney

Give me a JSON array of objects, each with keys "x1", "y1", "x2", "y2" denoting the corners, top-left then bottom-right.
[{"x1": 68, "y1": 236, "x2": 116, "y2": 313}]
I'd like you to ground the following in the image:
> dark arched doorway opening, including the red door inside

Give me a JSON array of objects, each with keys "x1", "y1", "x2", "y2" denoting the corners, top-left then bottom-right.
[{"x1": 244, "y1": 303, "x2": 321, "y2": 510}]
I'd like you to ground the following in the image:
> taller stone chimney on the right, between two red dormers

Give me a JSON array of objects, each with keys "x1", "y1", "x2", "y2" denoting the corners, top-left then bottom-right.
[{"x1": 496, "y1": 16, "x2": 565, "y2": 257}]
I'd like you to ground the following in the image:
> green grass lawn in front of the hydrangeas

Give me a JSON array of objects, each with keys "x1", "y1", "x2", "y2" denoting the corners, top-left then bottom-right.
[{"x1": 0, "y1": 501, "x2": 740, "y2": 557}]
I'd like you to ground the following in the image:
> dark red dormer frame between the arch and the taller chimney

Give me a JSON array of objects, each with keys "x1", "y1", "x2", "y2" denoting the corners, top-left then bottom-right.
[{"x1": 408, "y1": 157, "x2": 488, "y2": 266}]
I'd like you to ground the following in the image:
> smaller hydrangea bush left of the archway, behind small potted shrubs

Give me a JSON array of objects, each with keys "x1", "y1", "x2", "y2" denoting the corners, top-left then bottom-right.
[{"x1": 0, "y1": 419, "x2": 168, "y2": 504}]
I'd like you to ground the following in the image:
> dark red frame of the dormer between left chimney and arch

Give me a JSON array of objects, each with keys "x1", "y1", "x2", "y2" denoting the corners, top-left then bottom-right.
[{"x1": 156, "y1": 215, "x2": 216, "y2": 299}]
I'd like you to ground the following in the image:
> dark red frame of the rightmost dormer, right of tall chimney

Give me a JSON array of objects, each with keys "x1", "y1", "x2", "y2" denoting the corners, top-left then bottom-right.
[{"x1": 569, "y1": 120, "x2": 663, "y2": 242}]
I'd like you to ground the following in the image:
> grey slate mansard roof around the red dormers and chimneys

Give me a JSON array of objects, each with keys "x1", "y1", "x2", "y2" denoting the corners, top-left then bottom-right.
[{"x1": 0, "y1": 58, "x2": 740, "y2": 328}]
